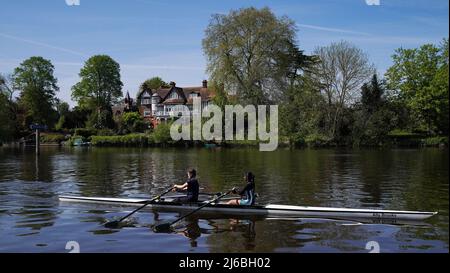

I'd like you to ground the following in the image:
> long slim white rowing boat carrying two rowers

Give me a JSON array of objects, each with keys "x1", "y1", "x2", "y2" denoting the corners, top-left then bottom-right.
[{"x1": 59, "y1": 195, "x2": 437, "y2": 221}]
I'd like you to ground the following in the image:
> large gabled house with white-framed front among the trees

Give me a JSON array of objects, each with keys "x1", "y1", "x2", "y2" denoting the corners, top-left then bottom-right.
[{"x1": 137, "y1": 80, "x2": 214, "y2": 126}]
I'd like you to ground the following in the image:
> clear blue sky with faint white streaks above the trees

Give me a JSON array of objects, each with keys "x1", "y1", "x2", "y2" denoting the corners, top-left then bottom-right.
[{"x1": 0, "y1": 0, "x2": 449, "y2": 105}]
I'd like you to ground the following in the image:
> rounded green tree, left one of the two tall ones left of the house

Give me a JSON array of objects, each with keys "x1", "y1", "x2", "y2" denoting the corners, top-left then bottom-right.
[{"x1": 12, "y1": 57, "x2": 59, "y2": 127}]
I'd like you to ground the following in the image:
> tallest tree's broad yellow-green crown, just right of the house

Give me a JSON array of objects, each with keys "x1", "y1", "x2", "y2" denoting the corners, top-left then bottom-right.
[{"x1": 202, "y1": 8, "x2": 303, "y2": 105}]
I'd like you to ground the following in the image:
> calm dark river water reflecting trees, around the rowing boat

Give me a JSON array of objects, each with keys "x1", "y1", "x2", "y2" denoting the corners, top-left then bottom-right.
[{"x1": 0, "y1": 147, "x2": 449, "y2": 252}]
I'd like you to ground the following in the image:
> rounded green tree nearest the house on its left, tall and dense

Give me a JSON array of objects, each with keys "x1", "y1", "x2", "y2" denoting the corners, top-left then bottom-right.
[{"x1": 72, "y1": 55, "x2": 123, "y2": 128}]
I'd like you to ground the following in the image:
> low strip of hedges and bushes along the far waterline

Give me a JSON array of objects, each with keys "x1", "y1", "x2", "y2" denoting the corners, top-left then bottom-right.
[{"x1": 0, "y1": 129, "x2": 449, "y2": 149}]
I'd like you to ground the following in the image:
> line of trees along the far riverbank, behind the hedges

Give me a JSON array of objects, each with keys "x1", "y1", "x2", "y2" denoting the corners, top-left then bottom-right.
[{"x1": 0, "y1": 8, "x2": 449, "y2": 146}]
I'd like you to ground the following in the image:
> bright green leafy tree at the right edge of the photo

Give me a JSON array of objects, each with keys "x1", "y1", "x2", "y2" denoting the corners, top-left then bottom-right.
[{"x1": 386, "y1": 39, "x2": 449, "y2": 134}]
